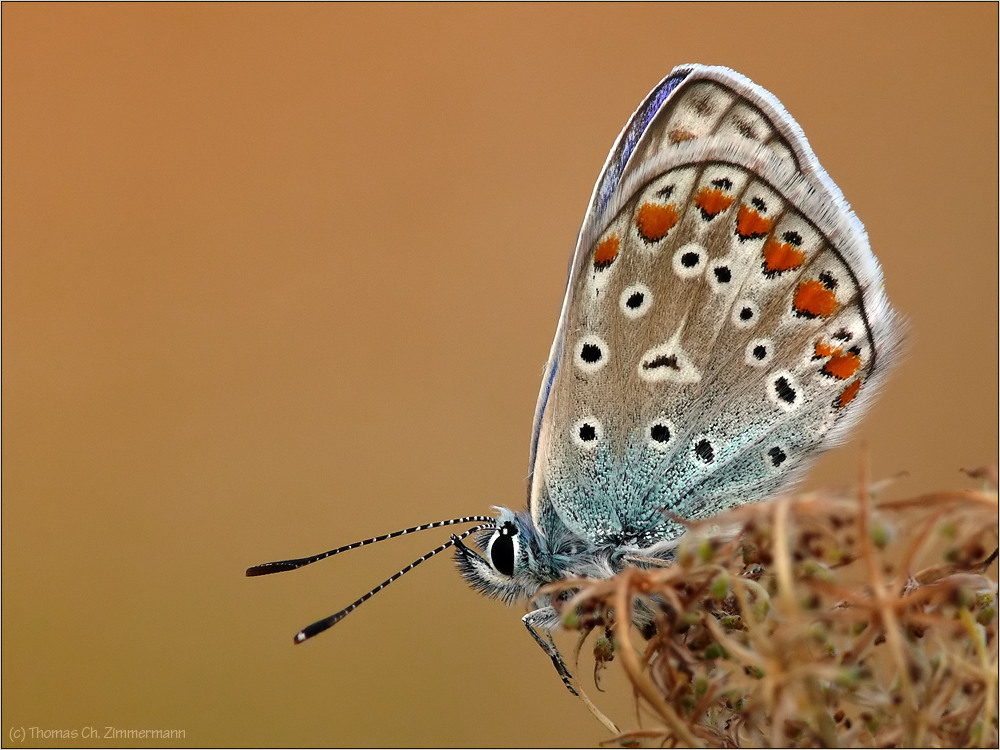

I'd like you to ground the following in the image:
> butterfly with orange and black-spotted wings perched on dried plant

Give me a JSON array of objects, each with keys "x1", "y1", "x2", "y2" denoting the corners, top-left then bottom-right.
[{"x1": 247, "y1": 65, "x2": 902, "y2": 704}]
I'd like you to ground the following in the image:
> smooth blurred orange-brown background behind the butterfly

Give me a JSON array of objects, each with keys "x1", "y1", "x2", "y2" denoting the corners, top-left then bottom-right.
[{"x1": 2, "y1": 4, "x2": 998, "y2": 746}]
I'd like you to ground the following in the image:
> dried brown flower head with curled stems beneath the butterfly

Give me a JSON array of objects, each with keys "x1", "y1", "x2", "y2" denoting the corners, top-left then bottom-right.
[{"x1": 548, "y1": 470, "x2": 998, "y2": 747}]
